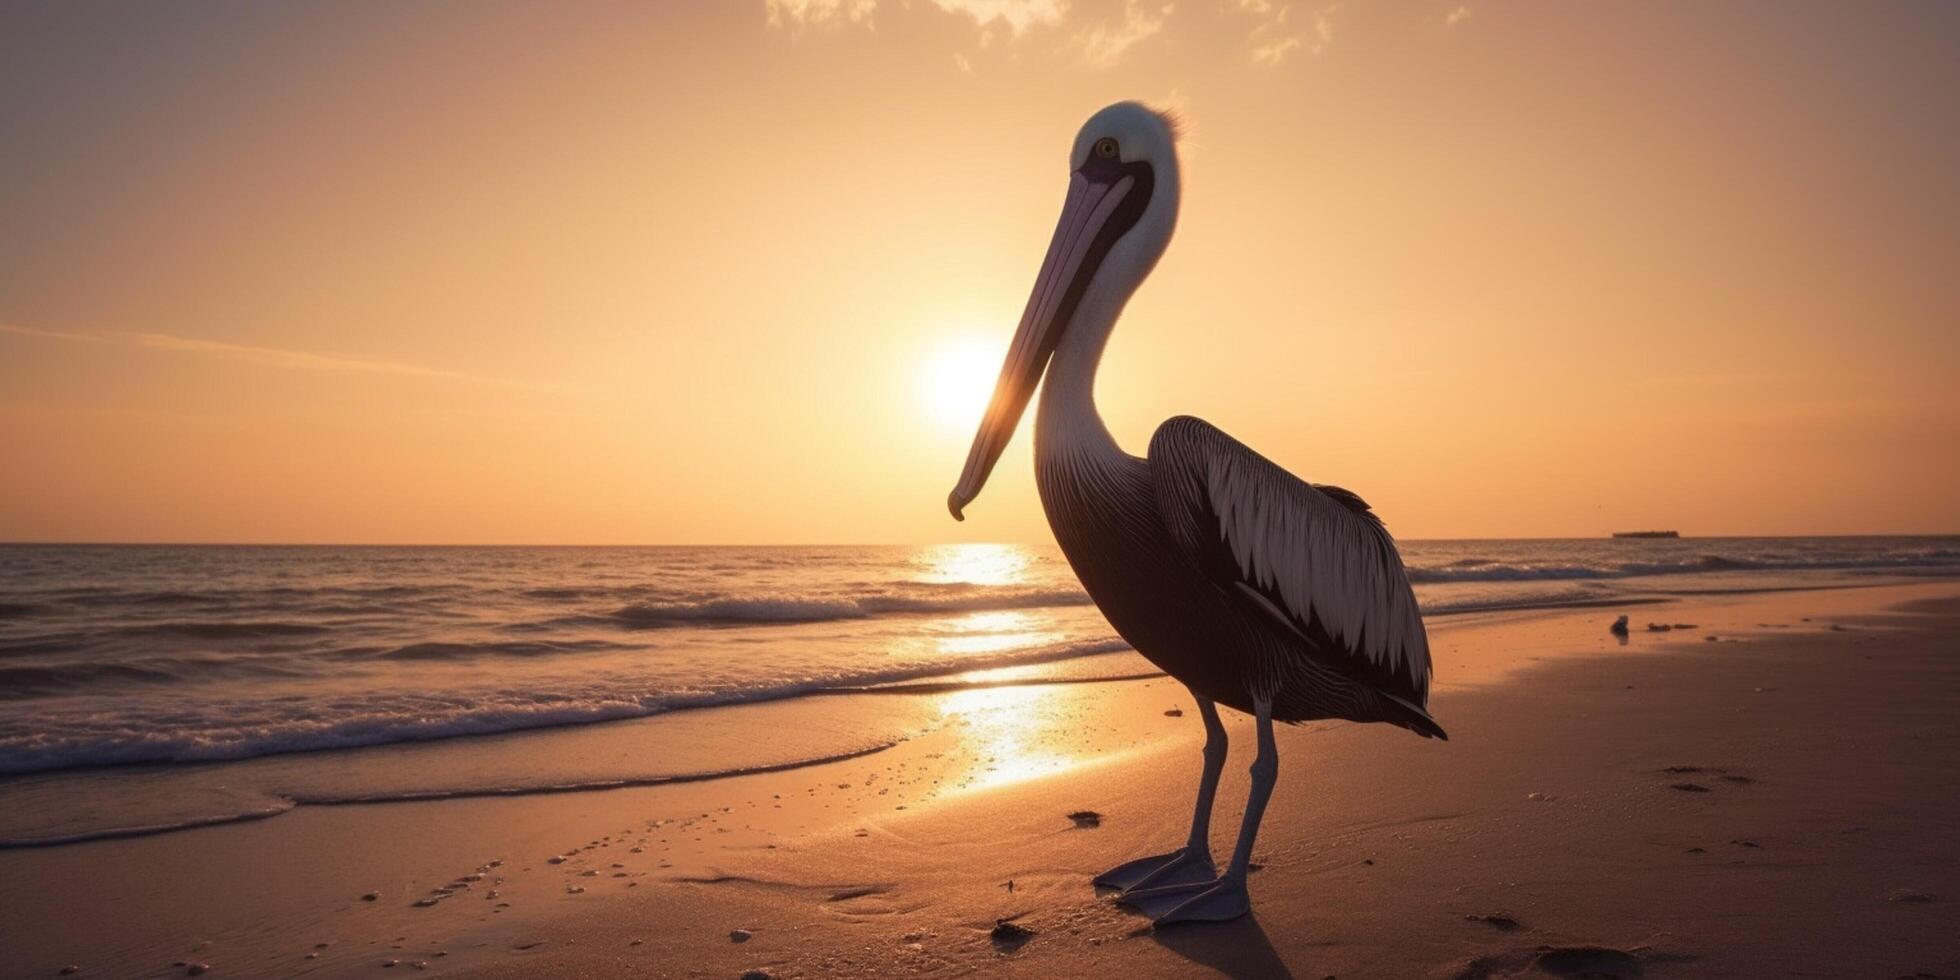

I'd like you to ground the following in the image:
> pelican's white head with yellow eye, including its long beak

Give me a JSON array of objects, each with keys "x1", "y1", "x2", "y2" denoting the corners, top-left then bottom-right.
[{"x1": 947, "y1": 102, "x2": 1178, "y2": 519}]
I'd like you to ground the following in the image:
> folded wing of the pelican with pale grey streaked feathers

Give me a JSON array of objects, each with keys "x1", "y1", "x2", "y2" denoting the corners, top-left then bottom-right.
[{"x1": 1151, "y1": 417, "x2": 1429, "y2": 710}]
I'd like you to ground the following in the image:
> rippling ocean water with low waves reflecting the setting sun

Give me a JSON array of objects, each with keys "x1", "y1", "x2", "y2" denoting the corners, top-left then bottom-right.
[{"x1": 0, "y1": 537, "x2": 1960, "y2": 847}]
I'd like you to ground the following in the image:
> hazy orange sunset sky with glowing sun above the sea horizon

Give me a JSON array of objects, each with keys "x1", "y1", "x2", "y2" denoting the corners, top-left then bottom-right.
[{"x1": 0, "y1": 0, "x2": 1960, "y2": 543}]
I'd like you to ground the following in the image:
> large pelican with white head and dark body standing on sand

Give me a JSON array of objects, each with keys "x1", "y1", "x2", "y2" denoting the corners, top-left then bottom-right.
[{"x1": 947, "y1": 102, "x2": 1446, "y2": 925}]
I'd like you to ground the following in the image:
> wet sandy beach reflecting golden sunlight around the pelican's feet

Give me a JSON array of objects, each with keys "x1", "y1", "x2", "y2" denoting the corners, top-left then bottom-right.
[{"x1": 0, "y1": 582, "x2": 1960, "y2": 978}]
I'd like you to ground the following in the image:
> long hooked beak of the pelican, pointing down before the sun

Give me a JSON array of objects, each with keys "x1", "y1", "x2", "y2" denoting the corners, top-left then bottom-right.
[{"x1": 947, "y1": 171, "x2": 1135, "y2": 521}]
